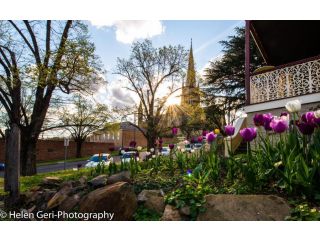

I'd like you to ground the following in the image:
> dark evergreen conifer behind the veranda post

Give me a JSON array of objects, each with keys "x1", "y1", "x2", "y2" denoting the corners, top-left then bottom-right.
[{"x1": 204, "y1": 28, "x2": 263, "y2": 126}]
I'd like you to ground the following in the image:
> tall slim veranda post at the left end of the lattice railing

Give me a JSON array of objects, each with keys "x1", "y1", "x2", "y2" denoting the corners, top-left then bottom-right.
[{"x1": 245, "y1": 20, "x2": 250, "y2": 105}]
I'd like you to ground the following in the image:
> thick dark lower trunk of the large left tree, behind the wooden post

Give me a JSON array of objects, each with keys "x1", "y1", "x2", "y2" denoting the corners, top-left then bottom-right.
[{"x1": 20, "y1": 129, "x2": 38, "y2": 176}]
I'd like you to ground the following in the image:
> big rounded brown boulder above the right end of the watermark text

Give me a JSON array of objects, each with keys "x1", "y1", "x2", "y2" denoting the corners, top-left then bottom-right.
[{"x1": 80, "y1": 182, "x2": 137, "y2": 221}]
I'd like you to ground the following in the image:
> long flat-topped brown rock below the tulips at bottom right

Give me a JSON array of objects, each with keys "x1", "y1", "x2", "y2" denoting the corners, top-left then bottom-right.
[{"x1": 198, "y1": 194, "x2": 290, "y2": 221}]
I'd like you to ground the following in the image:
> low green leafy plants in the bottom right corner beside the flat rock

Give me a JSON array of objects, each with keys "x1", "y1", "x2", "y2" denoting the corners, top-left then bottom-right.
[{"x1": 286, "y1": 203, "x2": 320, "y2": 221}]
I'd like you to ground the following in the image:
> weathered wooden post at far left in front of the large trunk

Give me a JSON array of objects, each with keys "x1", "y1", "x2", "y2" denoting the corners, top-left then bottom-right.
[{"x1": 4, "y1": 123, "x2": 20, "y2": 208}]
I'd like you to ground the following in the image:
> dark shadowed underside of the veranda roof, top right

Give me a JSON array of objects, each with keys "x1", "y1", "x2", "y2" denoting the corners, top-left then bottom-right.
[{"x1": 249, "y1": 20, "x2": 320, "y2": 66}]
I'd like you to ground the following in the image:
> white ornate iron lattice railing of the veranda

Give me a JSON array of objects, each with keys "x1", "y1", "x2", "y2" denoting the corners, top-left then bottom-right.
[{"x1": 250, "y1": 59, "x2": 320, "y2": 104}]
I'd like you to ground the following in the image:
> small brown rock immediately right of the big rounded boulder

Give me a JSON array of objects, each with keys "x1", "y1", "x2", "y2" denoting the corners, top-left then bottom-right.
[{"x1": 138, "y1": 190, "x2": 165, "y2": 214}]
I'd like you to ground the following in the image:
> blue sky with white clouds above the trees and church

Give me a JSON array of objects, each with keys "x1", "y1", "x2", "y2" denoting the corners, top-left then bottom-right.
[{"x1": 88, "y1": 20, "x2": 244, "y2": 109}]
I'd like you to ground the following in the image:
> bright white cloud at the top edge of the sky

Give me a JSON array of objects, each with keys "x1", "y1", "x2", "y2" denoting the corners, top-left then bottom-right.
[{"x1": 90, "y1": 20, "x2": 165, "y2": 44}]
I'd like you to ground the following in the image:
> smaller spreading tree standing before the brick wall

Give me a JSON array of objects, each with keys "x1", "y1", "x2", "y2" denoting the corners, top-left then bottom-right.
[{"x1": 57, "y1": 94, "x2": 110, "y2": 158}]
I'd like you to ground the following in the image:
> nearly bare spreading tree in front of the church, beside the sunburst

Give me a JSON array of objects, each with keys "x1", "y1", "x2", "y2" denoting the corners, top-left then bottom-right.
[{"x1": 115, "y1": 40, "x2": 187, "y2": 149}]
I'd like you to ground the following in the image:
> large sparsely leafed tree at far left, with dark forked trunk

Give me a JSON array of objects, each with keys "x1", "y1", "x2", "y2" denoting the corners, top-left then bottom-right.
[{"x1": 0, "y1": 20, "x2": 102, "y2": 175}]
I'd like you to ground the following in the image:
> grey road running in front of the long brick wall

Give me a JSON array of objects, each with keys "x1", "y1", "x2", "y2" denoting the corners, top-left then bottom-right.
[{"x1": 0, "y1": 156, "x2": 120, "y2": 177}]
